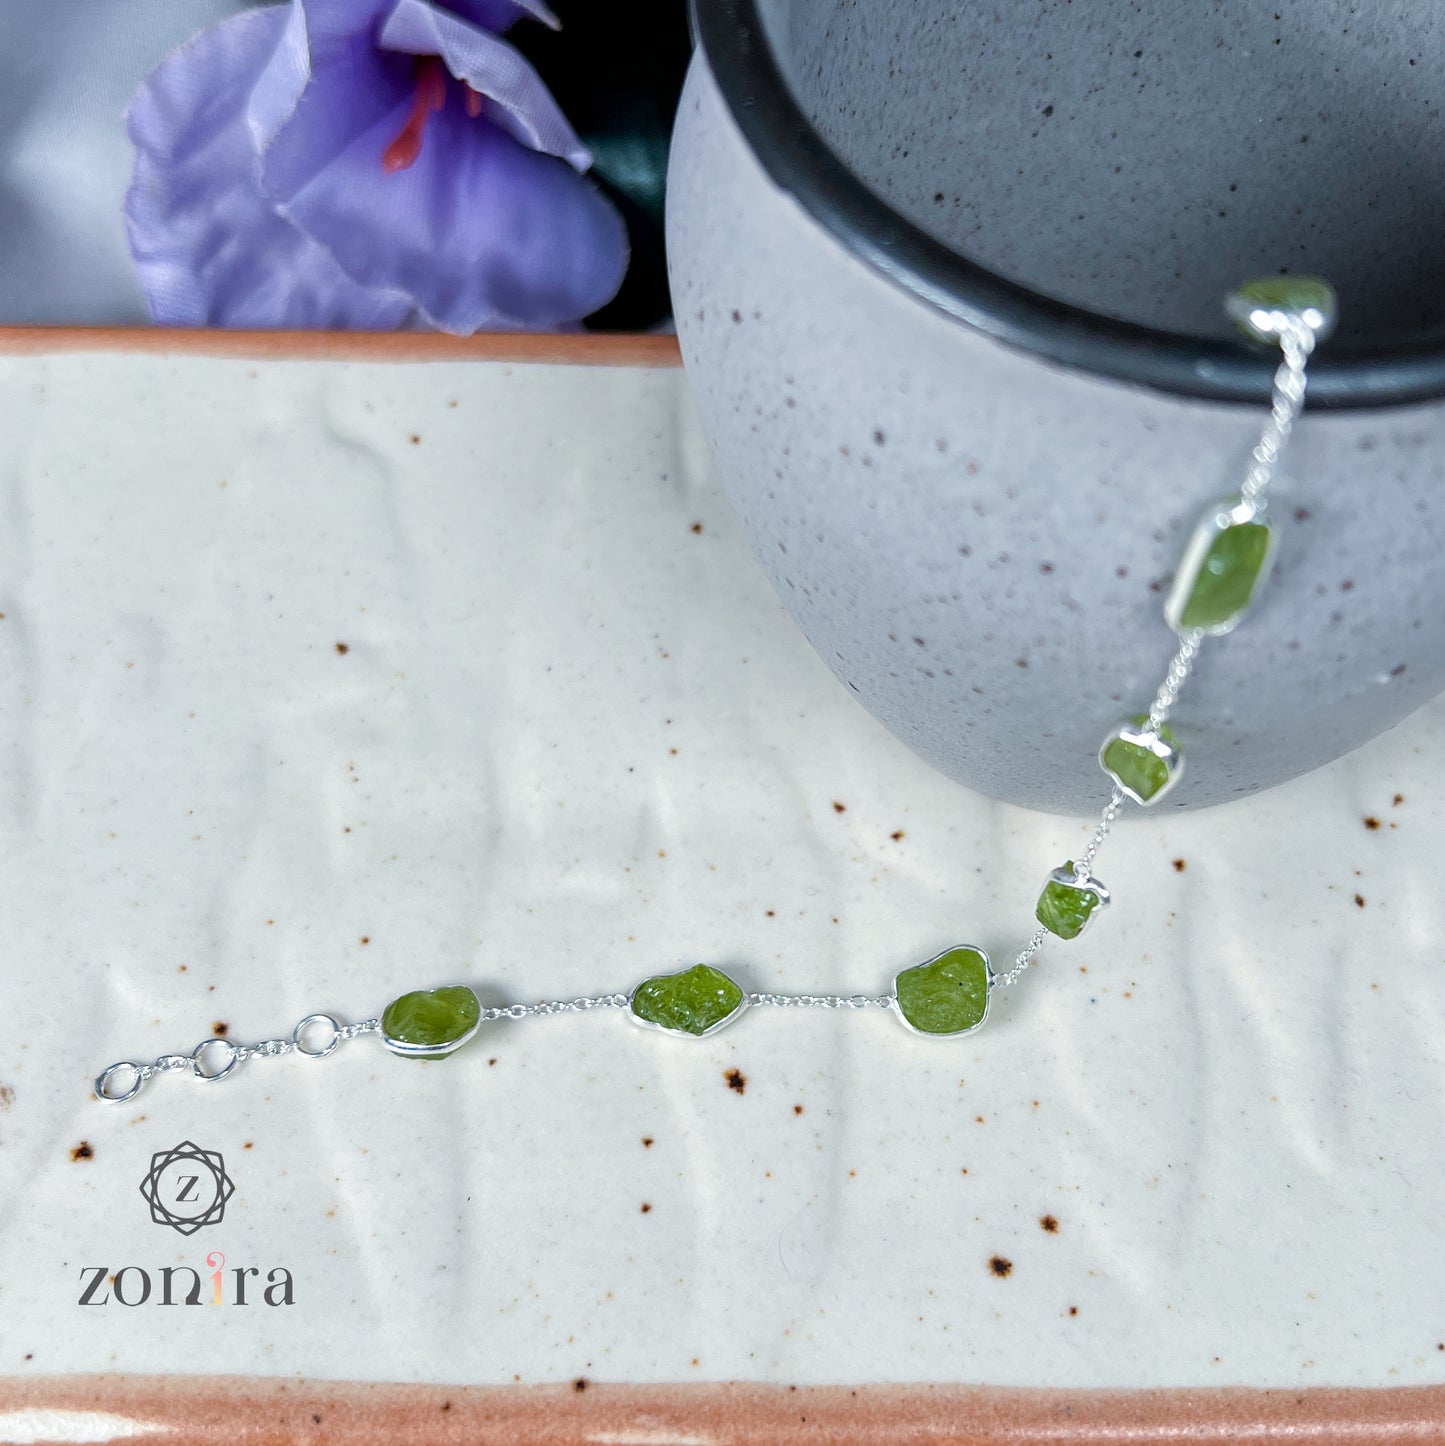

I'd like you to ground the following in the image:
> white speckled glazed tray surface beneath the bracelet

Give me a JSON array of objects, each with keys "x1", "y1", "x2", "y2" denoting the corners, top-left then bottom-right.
[{"x1": 0, "y1": 356, "x2": 1445, "y2": 1385}]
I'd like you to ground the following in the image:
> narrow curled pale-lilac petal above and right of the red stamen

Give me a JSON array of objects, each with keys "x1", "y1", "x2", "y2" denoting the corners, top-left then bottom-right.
[{"x1": 379, "y1": 0, "x2": 592, "y2": 171}]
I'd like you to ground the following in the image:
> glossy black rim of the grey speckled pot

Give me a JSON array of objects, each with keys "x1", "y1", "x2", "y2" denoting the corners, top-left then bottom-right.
[{"x1": 693, "y1": 0, "x2": 1445, "y2": 411}]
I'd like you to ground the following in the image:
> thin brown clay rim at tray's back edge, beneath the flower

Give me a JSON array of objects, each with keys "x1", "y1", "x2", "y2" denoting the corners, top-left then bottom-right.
[{"x1": 0, "y1": 327, "x2": 681, "y2": 367}]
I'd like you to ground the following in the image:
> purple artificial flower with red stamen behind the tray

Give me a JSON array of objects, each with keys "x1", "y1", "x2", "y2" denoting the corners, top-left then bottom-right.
[{"x1": 126, "y1": 0, "x2": 628, "y2": 334}]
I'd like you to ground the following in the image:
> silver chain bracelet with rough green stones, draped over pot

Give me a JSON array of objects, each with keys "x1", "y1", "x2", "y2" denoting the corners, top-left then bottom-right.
[{"x1": 95, "y1": 276, "x2": 1337, "y2": 1105}]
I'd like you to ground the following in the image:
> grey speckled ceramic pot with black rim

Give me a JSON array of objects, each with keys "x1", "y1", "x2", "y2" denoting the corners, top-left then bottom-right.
[{"x1": 670, "y1": 0, "x2": 1445, "y2": 814}]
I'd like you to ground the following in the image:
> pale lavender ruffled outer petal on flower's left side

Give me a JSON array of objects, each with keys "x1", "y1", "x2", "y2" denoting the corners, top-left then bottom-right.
[{"x1": 126, "y1": 7, "x2": 414, "y2": 328}]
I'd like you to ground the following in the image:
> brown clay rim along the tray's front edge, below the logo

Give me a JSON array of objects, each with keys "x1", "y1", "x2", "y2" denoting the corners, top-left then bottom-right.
[{"x1": 0, "y1": 1375, "x2": 1445, "y2": 1446}]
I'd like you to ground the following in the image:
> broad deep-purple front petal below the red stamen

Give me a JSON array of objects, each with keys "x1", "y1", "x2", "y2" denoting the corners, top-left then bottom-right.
[{"x1": 273, "y1": 98, "x2": 628, "y2": 334}]
